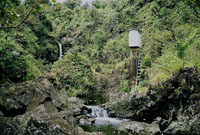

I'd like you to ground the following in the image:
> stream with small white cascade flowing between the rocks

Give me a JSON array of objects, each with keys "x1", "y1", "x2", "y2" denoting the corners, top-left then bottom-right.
[{"x1": 79, "y1": 96, "x2": 128, "y2": 135}]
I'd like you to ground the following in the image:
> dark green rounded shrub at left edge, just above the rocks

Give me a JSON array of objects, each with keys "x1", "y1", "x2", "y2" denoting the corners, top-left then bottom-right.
[{"x1": 0, "y1": 34, "x2": 39, "y2": 83}]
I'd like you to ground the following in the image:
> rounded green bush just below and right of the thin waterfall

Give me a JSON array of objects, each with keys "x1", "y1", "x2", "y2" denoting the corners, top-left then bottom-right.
[{"x1": 52, "y1": 52, "x2": 93, "y2": 96}]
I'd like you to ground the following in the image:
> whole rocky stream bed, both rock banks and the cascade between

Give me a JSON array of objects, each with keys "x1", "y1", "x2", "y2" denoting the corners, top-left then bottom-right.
[{"x1": 0, "y1": 68, "x2": 200, "y2": 135}]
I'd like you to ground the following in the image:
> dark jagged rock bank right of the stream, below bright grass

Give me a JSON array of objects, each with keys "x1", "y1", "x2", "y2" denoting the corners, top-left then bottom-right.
[{"x1": 108, "y1": 68, "x2": 200, "y2": 135}]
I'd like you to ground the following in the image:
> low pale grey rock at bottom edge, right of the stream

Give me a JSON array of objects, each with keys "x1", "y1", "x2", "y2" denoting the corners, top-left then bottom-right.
[{"x1": 115, "y1": 121, "x2": 162, "y2": 135}]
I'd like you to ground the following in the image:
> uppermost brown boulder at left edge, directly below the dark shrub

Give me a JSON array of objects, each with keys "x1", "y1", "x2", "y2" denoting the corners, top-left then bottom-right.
[{"x1": 0, "y1": 78, "x2": 53, "y2": 117}]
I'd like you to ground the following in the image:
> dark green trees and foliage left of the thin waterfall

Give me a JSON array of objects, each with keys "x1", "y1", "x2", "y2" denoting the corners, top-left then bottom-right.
[{"x1": 0, "y1": 0, "x2": 58, "y2": 84}]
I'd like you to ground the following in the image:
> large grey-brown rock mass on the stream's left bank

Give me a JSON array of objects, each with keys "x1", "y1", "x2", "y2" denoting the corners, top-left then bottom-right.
[{"x1": 0, "y1": 77, "x2": 90, "y2": 135}]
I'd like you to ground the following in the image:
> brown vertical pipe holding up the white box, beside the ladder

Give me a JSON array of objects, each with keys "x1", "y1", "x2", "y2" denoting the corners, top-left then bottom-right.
[{"x1": 130, "y1": 48, "x2": 137, "y2": 86}]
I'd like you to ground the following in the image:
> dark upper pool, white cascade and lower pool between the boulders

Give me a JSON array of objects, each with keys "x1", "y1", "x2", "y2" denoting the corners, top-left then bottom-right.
[{"x1": 79, "y1": 93, "x2": 127, "y2": 135}]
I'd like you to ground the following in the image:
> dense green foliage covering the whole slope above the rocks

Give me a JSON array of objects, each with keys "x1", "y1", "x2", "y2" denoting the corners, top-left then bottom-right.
[{"x1": 0, "y1": 0, "x2": 200, "y2": 95}]
